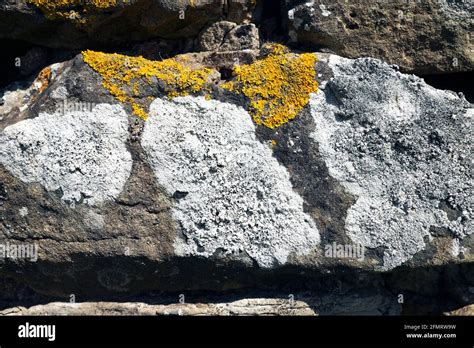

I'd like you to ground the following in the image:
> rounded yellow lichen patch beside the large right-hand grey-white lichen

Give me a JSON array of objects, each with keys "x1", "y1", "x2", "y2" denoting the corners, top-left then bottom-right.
[{"x1": 222, "y1": 44, "x2": 318, "y2": 128}]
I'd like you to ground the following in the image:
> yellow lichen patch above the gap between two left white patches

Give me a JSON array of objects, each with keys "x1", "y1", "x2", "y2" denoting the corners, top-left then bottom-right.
[{"x1": 82, "y1": 50, "x2": 212, "y2": 119}]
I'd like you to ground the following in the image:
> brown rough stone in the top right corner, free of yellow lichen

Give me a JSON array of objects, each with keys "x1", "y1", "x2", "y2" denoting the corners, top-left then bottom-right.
[{"x1": 287, "y1": 0, "x2": 474, "y2": 74}]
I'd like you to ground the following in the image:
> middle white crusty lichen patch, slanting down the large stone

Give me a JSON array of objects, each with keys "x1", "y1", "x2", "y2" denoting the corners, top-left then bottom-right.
[{"x1": 142, "y1": 97, "x2": 319, "y2": 267}]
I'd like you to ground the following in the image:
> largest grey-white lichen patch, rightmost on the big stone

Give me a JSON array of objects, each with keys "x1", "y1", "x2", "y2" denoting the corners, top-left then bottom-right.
[{"x1": 311, "y1": 56, "x2": 474, "y2": 270}]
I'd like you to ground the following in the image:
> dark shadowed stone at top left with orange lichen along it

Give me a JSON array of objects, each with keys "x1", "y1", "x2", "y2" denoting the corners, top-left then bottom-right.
[{"x1": 0, "y1": 0, "x2": 252, "y2": 49}]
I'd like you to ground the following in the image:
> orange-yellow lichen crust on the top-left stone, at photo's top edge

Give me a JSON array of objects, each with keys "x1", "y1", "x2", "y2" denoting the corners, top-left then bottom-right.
[{"x1": 27, "y1": 0, "x2": 119, "y2": 24}]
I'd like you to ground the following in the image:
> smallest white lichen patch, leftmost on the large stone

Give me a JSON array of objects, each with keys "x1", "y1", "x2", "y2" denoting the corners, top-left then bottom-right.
[{"x1": 0, "y1": 104, "x2": 132, "y2": 205}]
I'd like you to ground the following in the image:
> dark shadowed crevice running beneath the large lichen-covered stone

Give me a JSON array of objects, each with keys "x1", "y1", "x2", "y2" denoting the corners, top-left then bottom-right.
[{"x1": 0, "y1": 254, "x2": 474, "y2": 315}]
